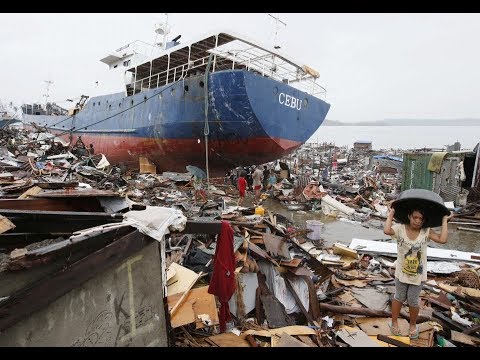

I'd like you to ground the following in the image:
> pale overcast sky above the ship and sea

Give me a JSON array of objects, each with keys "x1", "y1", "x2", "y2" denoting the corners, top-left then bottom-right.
[{"x1": 0, "y1": 13, "x2": 480, "y2": 122}]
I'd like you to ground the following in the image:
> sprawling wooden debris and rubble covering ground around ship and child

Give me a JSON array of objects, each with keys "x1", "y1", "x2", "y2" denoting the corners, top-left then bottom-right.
[{"x1": 0, "y1": 128, "x2": 480, "y2": 347}]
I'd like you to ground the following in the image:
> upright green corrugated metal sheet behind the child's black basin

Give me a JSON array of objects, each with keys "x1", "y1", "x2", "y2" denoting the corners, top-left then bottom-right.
[{"x1": 402, "y1": 153, "x2": 433, "y2": 191}]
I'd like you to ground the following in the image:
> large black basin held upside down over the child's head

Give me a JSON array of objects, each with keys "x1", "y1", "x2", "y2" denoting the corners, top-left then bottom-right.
[{"x1": 392, "y1": 189, "x2": 450, "y2": 228}]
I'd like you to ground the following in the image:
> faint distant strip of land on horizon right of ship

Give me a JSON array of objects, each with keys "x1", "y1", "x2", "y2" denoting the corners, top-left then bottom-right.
[{"x1": 322, "y1": 119, "x2": 480, "y2": 126}]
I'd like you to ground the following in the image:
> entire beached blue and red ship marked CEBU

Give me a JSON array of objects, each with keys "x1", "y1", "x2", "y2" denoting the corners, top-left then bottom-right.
[{"x1": 23, "y1": 27, "x2": 330, "y2": 175}]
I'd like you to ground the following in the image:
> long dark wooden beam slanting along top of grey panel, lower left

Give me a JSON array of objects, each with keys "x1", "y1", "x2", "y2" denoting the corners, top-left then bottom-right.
[{"x1": 0, "y1": 230, "x2": 154, "y2": 331}]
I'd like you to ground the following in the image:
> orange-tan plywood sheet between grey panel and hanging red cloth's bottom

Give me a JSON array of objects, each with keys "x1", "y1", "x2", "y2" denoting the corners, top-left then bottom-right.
[{"x1": 167, "y1": 286, "x2": 219, "y2": 329}]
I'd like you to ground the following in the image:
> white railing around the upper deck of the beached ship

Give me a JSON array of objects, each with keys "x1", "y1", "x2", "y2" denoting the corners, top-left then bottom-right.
[{"x1": 127, "y1": 50, "x2": 326, "y2": 96}]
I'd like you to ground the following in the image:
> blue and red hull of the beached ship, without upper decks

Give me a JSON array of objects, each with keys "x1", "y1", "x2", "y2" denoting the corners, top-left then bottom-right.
[{"x1": 24, "y1": 70, "x2": 330, "y2": 175}]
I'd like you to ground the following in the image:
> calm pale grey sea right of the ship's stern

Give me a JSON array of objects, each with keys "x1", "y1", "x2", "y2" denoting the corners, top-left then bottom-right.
[{"x1": 308, "y1": 125, "x2": 480, "y2": 150}]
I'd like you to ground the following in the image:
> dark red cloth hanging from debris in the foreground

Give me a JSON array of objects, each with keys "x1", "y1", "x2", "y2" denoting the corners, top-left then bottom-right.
[{"x1": 208, "y1": 220, "x2": 235, "y2": 332}]
